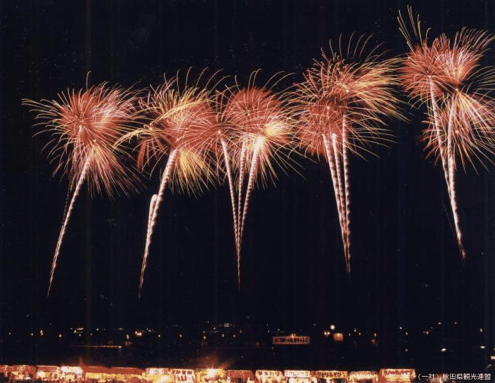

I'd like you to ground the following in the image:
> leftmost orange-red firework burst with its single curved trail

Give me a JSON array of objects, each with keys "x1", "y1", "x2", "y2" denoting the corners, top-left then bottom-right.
[{"x1": 23, "y1": 84, "x2": 140, "y2": 295}]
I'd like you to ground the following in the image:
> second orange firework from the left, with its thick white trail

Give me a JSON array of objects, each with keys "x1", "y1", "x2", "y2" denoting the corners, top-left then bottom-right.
[{"x1": 124, "y1": 73, "x2": 218, "y2": 295}]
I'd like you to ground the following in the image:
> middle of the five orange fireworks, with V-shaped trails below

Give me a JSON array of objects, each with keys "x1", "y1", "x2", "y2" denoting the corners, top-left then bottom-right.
[{"x1": 219, "y1": 72, "x2": 292, "y2": 287}]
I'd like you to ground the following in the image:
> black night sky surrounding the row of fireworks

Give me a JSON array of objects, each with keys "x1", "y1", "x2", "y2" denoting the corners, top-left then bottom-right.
[{"x1": 0, "y1": 0, "x2": 495, "y2": 362}]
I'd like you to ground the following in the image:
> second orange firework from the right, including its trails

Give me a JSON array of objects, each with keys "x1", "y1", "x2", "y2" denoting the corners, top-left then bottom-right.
[{"x1": 292, "y1": 37, "x2": 400, "y2": 272}]
